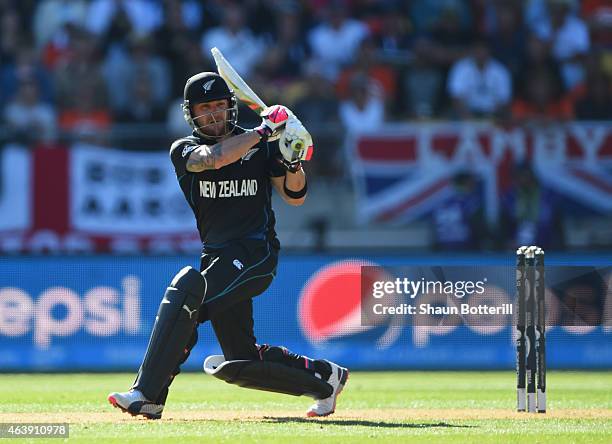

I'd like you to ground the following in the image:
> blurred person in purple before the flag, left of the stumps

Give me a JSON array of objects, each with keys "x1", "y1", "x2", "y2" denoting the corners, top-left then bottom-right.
[{"x1": 431, "y1": 172, "x2": 487, "y2": 251}]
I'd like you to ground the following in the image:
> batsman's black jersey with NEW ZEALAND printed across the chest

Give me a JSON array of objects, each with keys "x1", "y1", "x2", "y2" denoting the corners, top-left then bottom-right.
[{"x1": 170, "y1": 128, "x2": 285, "y2": 250}]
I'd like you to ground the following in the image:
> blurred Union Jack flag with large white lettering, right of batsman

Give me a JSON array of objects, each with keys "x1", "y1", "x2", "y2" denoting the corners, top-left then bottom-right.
[{"x1": 346, "y1": 123, "x2": 612, "y2": 224}]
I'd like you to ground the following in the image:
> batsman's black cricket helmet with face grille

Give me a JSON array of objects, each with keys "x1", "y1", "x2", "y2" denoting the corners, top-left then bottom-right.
[{"x1": 182, "y1": 72, "x2": 238, "y2": 139}]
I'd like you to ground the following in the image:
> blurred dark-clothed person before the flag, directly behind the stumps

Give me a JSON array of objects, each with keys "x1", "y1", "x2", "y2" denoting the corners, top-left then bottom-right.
[{"x1": 499, "y1": 164, "x2": 565, "y2": 250}]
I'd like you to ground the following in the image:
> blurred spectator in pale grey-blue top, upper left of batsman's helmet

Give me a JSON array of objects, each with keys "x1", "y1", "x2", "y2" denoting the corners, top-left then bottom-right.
[{"x1": 104, "y1": 35, "x2": 172, "y2": 114}]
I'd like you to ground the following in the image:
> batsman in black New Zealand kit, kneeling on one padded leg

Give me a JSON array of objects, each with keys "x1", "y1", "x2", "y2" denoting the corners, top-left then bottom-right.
[{"x1": 108, "y1": 72, "x2": 349, "y2": 419}]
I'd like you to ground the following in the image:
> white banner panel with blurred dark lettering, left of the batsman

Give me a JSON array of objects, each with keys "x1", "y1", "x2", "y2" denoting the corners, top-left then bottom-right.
[{"x1": 69, "y1": 145, "x2": 194, "y2": 235}]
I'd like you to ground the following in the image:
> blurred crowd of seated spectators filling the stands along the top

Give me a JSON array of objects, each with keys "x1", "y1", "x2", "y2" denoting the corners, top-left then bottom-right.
[{"x1": 0, "y1": 0, "x2": 612, "y2": 148}]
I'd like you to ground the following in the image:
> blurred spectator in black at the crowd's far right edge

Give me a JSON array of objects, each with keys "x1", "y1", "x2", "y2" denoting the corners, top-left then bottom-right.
[{"x1": 575, "y1": 72, "x2": 612, "y2": 121}]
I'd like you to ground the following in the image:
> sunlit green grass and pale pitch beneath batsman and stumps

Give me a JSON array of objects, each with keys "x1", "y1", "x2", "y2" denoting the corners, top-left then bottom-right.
[{"x1": 0, "y1": 371, "x2": 612, "y2": 444}]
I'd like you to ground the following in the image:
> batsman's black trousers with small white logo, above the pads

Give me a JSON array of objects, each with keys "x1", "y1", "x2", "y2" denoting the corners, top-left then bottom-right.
[{"x1": 156, "y1": 240, "x2": 278, "y2": 404}]
